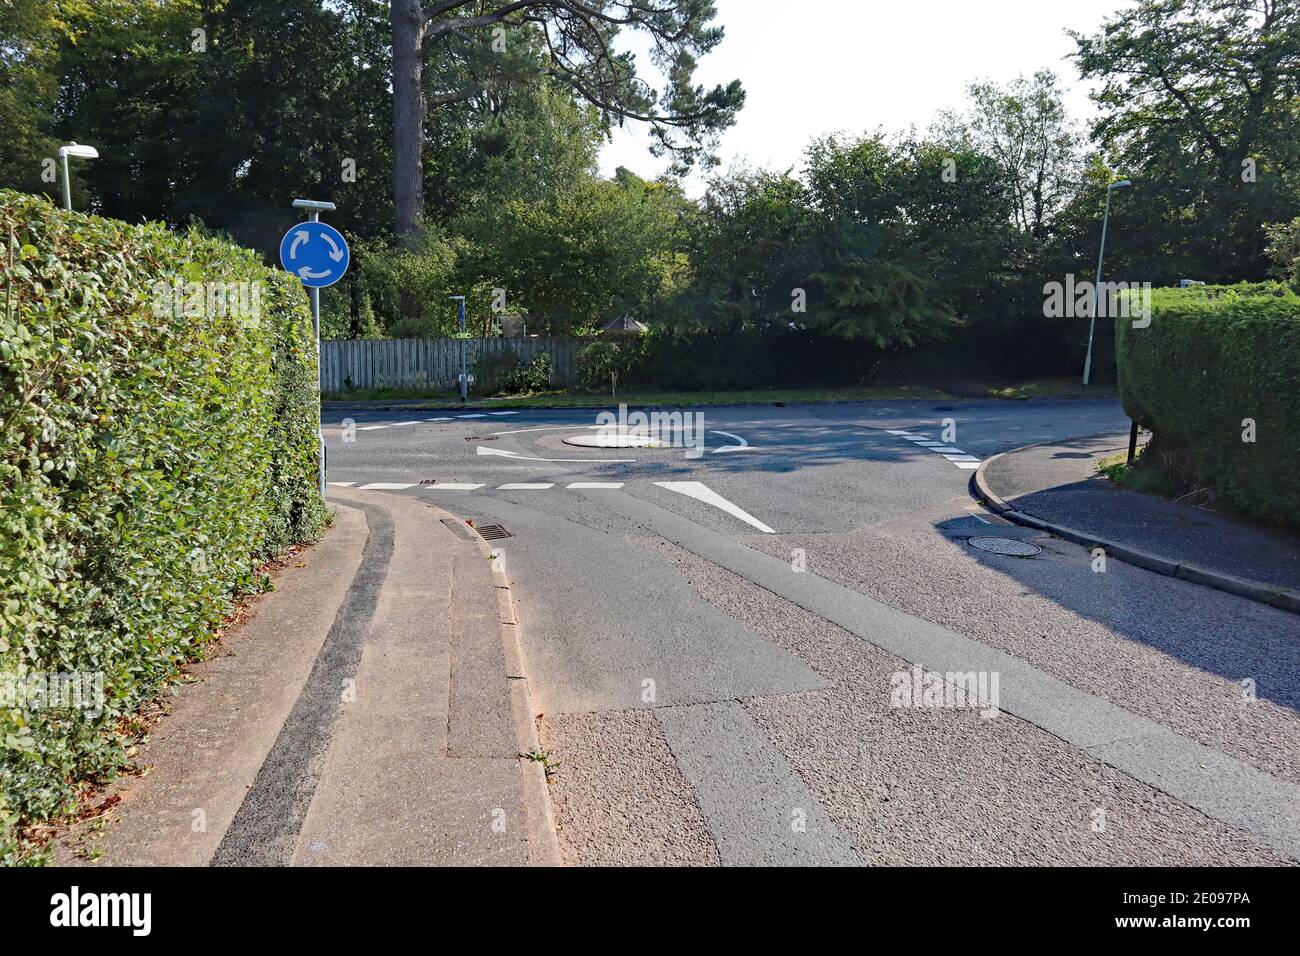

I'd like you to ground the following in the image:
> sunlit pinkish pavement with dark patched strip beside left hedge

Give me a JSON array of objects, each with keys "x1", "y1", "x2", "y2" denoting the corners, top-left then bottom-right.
[{"x1": 60, "y1": 492, "x2": 559, "y2": 866}]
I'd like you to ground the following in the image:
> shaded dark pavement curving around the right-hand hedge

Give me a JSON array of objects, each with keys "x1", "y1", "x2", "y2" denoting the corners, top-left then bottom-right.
[{"x1": 976, "y1": 433, "x2": 1300, "y2": 610}]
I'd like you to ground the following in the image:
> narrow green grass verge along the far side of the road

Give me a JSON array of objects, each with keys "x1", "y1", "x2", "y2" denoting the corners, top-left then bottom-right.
[{"x1": 324, "y1": 385, "x2": 952, "y2": 408}]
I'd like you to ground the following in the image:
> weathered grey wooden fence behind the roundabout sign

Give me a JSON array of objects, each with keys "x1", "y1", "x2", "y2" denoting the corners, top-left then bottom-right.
[{"x1": 321, "y1": 338, "x2": 581, "y2": 393}]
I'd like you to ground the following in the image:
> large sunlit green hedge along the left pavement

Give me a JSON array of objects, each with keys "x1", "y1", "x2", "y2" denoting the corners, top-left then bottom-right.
[{"x1": 0, "y1": 191, "x2": 326, "y2": 864}]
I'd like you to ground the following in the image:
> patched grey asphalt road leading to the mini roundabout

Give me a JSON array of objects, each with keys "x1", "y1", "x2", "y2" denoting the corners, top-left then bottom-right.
[{"x1": 317, "y1": 401, "x2": 1300, "y2": 865}]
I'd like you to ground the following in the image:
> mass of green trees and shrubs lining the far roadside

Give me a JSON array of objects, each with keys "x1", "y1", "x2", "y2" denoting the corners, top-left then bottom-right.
[{"x1": 0, "y1": 0, "x2": 1300, "y2": 390}]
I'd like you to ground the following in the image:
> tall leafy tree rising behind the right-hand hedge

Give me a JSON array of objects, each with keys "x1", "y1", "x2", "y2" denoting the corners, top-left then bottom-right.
[{"x1": 1074, "y1": 0, "x2": 1300, "y2": 281}]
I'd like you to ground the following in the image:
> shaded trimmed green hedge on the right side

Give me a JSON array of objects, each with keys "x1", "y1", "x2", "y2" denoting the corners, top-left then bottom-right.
[{"x1": 1115, "y1": 284, "x2": 1300, "y2": 529}]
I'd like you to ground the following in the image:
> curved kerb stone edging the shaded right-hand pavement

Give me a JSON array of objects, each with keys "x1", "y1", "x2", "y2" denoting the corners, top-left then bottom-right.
[{"x1": 971, "y1": 441, "x2": 1300, "y2": 614}]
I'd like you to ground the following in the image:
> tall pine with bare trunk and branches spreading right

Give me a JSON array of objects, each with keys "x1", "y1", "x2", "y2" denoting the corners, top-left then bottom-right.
[{"x1": 390, "y1": 0, "x2": 745, "y2": 245}]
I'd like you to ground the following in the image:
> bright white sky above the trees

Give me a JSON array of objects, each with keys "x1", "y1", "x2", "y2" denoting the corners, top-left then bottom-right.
[{"x1": 601, "y1": 0, "x2": 1132, "y2": 194}]
